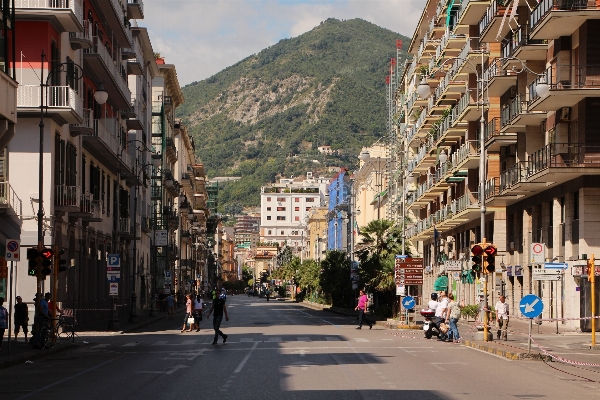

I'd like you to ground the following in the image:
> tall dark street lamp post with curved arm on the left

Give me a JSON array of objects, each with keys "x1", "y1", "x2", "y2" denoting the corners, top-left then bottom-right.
[{"x1": 34, "y1": 50, "x2": 108, "y2": 333}]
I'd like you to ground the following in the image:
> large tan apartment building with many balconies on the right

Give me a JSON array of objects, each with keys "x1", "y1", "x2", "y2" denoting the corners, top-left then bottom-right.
[{"x1": 397, "y1": 0, "x2": 600, "y2": 330}]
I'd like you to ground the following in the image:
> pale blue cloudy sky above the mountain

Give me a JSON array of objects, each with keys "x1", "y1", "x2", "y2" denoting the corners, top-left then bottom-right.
[{"x1": 143, "y1": 0, "x2": 426, "y2": 87}]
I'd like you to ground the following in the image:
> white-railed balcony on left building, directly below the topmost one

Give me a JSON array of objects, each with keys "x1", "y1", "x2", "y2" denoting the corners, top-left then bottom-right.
[{"x1": 17, "y1": 85, "x2": 83, "y2": 125}]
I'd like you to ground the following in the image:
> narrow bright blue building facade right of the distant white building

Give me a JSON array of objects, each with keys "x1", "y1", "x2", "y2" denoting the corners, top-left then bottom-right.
[{"x1": 327, "y1": 168, "x2": 352, "y2": 252}]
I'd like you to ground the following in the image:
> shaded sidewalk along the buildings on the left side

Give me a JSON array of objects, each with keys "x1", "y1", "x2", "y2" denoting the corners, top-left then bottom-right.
[{"x1": 0, "y1": 307, "x2": 185, "y2": 369}]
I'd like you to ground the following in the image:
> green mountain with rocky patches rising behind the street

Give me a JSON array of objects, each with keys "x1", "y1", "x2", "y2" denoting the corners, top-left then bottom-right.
[{"x1": 178, "y1": 19, "x2": 409, "y2": 210}]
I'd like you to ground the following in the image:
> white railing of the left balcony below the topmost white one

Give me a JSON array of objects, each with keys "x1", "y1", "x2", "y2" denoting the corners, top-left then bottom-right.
[{"x1": 17, "y1": 85, "x2": 83, "y2": 116}]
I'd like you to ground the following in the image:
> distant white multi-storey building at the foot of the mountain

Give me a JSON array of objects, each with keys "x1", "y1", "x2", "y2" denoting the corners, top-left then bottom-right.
[{"x1": 260, "y1": 172, "x2": 328, "y2": 250}]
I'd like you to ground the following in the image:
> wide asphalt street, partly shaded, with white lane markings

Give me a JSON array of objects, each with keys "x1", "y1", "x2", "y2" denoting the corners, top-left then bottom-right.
[{"x1": 0, "y1": 296, "x2": 600, "y2": 400}]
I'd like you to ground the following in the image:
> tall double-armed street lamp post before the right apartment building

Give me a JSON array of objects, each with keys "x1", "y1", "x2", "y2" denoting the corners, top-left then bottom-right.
[{"x1": 417, "y1": 53, "x2": 550, "y2": 342}]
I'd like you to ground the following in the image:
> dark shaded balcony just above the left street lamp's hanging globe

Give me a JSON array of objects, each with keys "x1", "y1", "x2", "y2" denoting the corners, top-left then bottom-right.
[{"x1": 83, "y1": 37, "x2": 131, "y2": 110}]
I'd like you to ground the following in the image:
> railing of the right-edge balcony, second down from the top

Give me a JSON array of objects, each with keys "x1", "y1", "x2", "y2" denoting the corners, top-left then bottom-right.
[{"x1": 529, "y1": 64, "x2": 600, "y2": 101}]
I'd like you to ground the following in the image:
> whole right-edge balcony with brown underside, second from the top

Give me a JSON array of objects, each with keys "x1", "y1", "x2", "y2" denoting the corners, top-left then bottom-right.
[{"x1": 529, "y1": 64, "x2": 600, "y2": 111}]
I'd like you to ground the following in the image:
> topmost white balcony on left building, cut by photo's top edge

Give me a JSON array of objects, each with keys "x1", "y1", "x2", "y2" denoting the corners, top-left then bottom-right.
[{"x1": 15, "y1": 0, "x2": 83, "y2": 32}]
